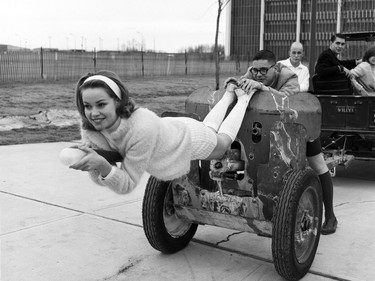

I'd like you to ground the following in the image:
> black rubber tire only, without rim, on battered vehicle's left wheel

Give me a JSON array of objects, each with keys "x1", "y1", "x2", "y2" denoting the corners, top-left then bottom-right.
[{"x1": 142, "y1": 176, "x2": 198, "y2": 254}]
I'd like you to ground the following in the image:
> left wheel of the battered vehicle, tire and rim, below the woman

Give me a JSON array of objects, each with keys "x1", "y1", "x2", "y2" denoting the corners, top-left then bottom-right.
[{"x1": 142, "y1": 176, "x2": 198, "y2": 254}]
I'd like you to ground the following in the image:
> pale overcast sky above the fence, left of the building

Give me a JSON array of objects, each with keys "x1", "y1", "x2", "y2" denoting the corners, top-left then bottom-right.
[{"x1": 0, "y1": 0, "x2": 226, "y2": 52}]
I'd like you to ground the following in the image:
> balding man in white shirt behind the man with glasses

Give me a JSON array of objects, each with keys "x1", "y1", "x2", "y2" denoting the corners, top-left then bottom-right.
[{"x1": 279, "y1": 42, "x2": 310, "y2": 92}]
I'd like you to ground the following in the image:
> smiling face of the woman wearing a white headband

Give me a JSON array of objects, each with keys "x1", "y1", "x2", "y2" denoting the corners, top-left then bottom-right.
[{"x1": 82, "y1": 88, "x2": 120, "y2": 131}]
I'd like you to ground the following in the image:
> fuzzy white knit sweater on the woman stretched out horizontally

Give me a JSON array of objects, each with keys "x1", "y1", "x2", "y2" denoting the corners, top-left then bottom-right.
[{"x1": 82, "y1": 108, "x2": 194, "y2": 193}]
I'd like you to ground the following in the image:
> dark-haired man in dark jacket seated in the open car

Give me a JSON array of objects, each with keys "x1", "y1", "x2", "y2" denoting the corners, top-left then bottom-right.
[{"x1": 315, "y1": 34, "x2": 361, "y2": 80}]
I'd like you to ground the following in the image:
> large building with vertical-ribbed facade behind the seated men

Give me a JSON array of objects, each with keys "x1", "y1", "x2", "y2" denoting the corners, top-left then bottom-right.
[{"x1": 226, "y1": 0, "x2": 375, "y2": 61}]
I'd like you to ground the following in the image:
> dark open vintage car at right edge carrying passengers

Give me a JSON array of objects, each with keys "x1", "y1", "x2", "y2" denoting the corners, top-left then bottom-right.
[{"x1": 312, "y1": 32, "x2": 375, "y2": 170}]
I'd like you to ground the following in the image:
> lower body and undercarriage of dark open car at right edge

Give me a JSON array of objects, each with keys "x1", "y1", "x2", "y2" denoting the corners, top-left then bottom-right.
[{"x1": 317, "y1": 92, "x2": 375, "y2": 160}]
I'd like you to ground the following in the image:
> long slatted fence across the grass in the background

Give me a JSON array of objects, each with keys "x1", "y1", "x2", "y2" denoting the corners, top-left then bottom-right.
[{"x1": 0, "y1": 48, "x2": 249, "y2": 82}]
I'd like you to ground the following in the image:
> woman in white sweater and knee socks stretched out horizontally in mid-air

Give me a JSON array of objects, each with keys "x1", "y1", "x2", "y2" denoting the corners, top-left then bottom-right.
[{"x1": 63, "y1": 71, "x2": 253, "y2": 193}]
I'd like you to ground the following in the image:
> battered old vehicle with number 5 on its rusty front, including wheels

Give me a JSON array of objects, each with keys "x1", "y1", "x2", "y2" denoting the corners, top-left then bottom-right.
[{"x1": 142, "y1": 88, "x2": 322, "y2": 280}]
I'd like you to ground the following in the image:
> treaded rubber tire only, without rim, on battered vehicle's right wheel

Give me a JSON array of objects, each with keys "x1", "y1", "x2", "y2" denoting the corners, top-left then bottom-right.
[{"x1": 272, "y1": 168, "x2": 323, "y2": 280}]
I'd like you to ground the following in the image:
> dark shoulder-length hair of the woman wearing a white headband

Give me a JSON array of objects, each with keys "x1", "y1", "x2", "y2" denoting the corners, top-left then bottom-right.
[{"x1": 75, "y1": 70, "x2": 135, "y2": 131}]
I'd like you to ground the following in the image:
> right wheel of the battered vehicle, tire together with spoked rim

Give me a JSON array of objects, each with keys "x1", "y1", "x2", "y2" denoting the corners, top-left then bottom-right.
[{"x1": 272, "y1": 168, "x2": 322, "y2": 280}]
